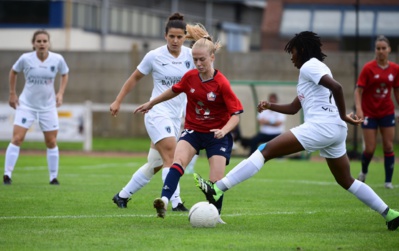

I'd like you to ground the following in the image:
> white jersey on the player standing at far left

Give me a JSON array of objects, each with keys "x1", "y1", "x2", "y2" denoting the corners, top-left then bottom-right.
[{"x1": 12, "y1": 51, "x2": 69, "y2": 111}]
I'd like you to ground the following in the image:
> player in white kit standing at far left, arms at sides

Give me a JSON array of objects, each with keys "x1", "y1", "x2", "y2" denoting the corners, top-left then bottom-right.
[{"x1": 3, "y1": 30, "x2": 69, "y2": 185}]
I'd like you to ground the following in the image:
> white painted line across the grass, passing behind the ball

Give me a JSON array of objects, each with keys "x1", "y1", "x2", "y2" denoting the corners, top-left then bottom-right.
[{"x1": 0, "y1": 211, "x2": 317, "y2": 220}]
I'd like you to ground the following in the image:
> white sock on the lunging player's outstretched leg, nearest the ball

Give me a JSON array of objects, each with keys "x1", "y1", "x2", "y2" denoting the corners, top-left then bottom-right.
[{"x1": 216, "y1": 150, "x2": 265, "y2": 191}]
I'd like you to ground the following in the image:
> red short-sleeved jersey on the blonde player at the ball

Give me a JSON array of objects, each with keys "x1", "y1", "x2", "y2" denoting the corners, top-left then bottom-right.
[{"x1": 172, "y1": 69, "x2": 244, "y2": 133}]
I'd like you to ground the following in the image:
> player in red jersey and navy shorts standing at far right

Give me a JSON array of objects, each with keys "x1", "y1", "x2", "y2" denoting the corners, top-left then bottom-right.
[{"x1": 355, "y1": 36, "x2": 399, "y2": 189}]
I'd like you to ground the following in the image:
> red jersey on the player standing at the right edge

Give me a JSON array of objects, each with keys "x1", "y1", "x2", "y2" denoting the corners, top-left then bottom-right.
[{"x1": 357, "y1": 60, "x2": 399, "y2": 119}]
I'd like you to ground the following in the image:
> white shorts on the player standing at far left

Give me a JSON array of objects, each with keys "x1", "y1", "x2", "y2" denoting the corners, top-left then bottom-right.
[{"x1": 14, "y1": 108, "x2": 59, "y2": 132}]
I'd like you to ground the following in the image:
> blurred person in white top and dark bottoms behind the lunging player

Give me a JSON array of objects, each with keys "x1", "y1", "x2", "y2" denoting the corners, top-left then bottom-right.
[{"x1": 249, "y1": 93, "x2": 286, "y2": 155}]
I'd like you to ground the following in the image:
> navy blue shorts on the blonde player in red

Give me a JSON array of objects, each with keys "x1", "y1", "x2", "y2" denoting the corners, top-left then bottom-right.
[{"x1": 179, "y1": 129, "x2": 233, "y2": 165}]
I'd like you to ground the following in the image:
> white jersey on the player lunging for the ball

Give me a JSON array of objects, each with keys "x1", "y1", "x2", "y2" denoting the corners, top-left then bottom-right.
[{"x1": 297, "y1": 58, "x2": 347, "y2": 127}]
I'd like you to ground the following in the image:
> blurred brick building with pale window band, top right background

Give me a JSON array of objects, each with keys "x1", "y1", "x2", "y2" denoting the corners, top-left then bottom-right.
[{"x1": 261, "y1": 0, "x2": 399, "y2": 51}]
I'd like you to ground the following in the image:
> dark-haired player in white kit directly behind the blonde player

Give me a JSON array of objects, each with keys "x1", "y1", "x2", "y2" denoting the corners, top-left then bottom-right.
[{"x1": 110, "y1": 13, "x2": 195, "y2": 211}]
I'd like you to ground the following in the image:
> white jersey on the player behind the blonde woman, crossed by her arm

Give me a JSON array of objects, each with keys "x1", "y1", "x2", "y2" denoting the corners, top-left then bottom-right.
[{"x1": 137, "y1": 45, "x2": 195, "y2": 118}]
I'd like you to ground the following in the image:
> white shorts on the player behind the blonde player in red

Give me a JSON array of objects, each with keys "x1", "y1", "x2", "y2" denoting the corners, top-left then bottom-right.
[{"x1": 144, "y1": 112, "x2": 181, "y2": 144}]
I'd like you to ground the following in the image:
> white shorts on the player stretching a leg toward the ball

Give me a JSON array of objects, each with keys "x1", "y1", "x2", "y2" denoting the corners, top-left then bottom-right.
[{"x1": 291, "y1": 122, "x2": 348, "y2": 159}]
